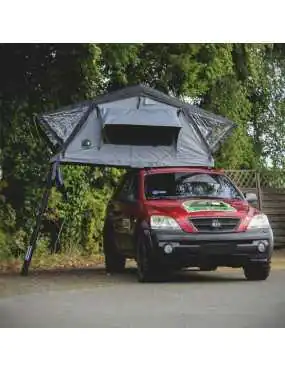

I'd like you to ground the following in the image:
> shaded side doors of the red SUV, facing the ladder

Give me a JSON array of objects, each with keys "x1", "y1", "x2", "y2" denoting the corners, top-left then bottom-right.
[{"x1": 109, "y1": 173, "x2": 139, "y2": 257}]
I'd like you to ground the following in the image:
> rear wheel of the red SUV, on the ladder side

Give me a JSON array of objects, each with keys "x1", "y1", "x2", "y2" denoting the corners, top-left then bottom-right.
[{"x1": 103, "y1": 222, "x2": 126, "y2": 273}]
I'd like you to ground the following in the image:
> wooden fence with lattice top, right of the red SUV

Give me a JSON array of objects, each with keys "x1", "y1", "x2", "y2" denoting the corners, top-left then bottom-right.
[{"x1": 225, "y1": 170, "x2": 285, "y2": 248}]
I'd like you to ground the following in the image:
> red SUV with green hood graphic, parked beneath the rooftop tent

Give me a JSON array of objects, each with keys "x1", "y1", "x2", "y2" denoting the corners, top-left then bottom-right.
[{"x1": 103, "y1": 167, "x2": 273, "y2": 282}]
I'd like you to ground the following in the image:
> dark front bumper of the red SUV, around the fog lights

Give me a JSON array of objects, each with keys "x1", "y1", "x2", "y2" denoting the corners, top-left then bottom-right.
[{"x1": 150, "y1": 229, "x2": 273, "y2": 267}]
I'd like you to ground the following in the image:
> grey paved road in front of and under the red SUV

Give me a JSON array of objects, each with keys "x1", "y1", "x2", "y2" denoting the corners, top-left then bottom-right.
[{"x1": 0, "y1": 269, "x2": 285, "y2": 327}]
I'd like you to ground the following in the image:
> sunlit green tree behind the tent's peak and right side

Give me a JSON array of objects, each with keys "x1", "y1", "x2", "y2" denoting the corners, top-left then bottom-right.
[{"x1": 100, "y1": 44, "x2": 256, "y2": 168}]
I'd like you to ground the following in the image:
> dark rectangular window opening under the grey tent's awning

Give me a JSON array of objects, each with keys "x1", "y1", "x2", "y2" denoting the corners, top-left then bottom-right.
[{"x1": 103, "y1": 125, "x2": 180, "y2": 146}]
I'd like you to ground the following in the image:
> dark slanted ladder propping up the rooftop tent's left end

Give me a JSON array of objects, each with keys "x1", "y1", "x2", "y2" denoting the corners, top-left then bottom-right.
[{"x1": 21, "y1": 163, "x2": 56, "y2": 276}]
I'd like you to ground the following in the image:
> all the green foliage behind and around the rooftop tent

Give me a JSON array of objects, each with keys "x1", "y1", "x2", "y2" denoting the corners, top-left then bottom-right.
[{"x1": 0, "y1": 43, "x2": 285, "y2": 259}]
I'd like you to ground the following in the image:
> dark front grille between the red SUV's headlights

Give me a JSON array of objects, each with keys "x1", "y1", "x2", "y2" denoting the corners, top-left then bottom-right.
[{"x1": 189, "y1": 218, "x2": 240, "y2": 233}]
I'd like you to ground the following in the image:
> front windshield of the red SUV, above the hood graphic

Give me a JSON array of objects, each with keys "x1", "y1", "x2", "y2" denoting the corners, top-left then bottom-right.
[{"x1": 145, "y1": 172, "x2": 243, "y2": 200}]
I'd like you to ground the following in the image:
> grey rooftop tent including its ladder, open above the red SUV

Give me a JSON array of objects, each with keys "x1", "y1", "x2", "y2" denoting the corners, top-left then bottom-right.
[{"x1": 22, "y1": 85, "x2": 235, "y2": 274}]
